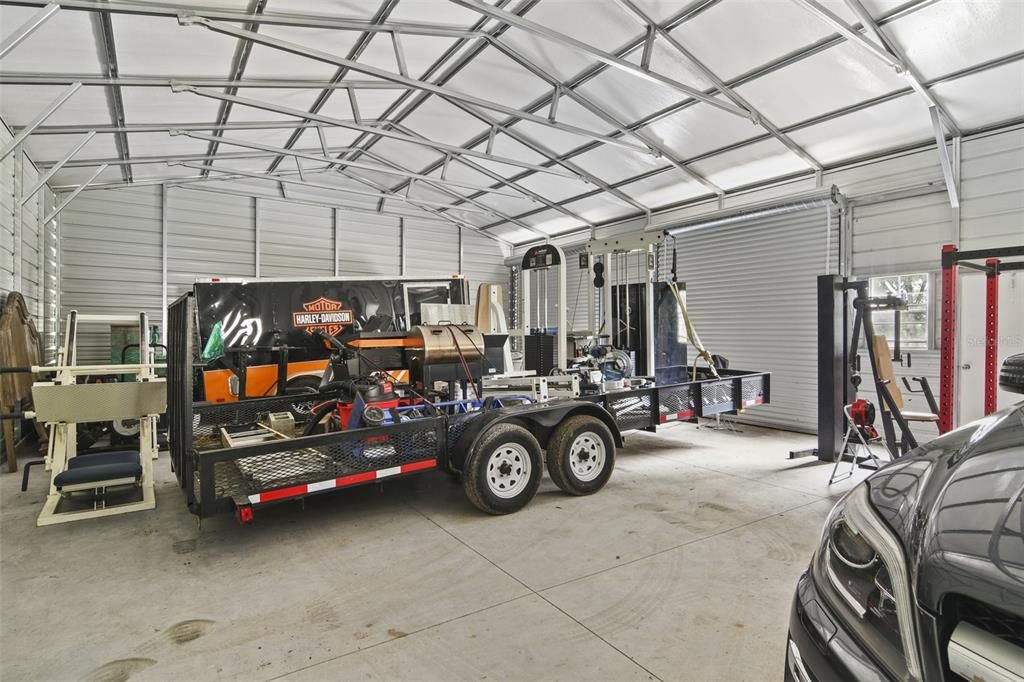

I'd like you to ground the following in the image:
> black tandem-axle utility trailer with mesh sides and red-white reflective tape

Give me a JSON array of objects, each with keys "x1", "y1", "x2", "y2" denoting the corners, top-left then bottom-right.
[{"x1": 167, "y1": 294, "x2": 770, "y2": 522}]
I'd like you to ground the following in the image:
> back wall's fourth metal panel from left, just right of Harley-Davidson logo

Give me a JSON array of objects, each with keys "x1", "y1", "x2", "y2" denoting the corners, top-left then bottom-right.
[{"x1": 338, "y1": 210, "x2": 399, "y2": 276}]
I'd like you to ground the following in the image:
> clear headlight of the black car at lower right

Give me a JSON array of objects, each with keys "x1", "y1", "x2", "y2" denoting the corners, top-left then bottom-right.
[{"x1": 811, "y1": 483, "x2": 922, "y2": 680}]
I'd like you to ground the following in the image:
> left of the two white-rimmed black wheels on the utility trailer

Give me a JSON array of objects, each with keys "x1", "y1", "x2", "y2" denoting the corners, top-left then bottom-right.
[{"x1": 462, "y1": 424, "x2": 544, "y2": 514}]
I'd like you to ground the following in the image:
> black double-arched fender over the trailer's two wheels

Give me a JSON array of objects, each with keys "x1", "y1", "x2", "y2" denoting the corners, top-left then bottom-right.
[{"x1": 449, "y1": 400, "x2": 623, "y2": 471}]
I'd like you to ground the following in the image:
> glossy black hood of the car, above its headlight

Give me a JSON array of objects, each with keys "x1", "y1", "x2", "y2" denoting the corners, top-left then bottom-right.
[{"x1": 868, "y1": 402, "x2": 1024, "y2": 617}]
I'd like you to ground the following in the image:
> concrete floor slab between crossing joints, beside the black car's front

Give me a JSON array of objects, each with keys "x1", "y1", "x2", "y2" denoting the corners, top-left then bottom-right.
[{"x1": 543, "y1": 493, "x2": 831, "y2": 682}]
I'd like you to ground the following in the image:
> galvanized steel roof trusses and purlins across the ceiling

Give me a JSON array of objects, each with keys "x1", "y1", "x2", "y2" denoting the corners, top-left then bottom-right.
[{"x1": 0, "y1": 0, "x2": 1024, "y2": 241}]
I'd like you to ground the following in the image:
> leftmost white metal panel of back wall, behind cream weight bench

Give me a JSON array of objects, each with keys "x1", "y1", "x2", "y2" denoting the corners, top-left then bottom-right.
[{"x1": 60, "y1": 187, "x2": 163, "y2": 363}]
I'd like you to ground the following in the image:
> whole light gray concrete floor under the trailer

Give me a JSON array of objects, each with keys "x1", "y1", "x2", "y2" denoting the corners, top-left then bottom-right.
[{"x1": 0, "y1": 425, "x2": 863, "y2": 682}]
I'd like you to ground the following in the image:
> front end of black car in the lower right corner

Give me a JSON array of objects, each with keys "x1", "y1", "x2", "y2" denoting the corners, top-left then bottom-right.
[{"x1": 785, "y1": 402, "x2": 1024, "y2": 682}]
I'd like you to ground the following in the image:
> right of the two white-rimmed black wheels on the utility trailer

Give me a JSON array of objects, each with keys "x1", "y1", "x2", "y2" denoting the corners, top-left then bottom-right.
[{"x1": 547, "y1": 415, "x2": 615, "y2": 495}]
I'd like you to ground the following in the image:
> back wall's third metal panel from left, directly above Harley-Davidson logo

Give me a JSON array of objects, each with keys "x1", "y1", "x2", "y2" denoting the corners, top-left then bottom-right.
[{"x1": 258, "y1": 199, "x2": 334, "y2": 279}]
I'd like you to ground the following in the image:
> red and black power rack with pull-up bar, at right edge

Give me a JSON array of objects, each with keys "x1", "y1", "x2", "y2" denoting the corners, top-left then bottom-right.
[{"x1": 939, "y1": 244, "x2": 1024, "y2": 433}]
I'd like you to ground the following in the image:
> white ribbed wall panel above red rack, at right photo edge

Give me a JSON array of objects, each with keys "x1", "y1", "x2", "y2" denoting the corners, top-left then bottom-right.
[{"x1": 961, "y1": 125, "x2": 1024, "y2": 249}]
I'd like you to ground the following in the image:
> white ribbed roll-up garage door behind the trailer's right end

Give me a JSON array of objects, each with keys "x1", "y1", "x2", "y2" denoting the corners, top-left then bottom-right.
[{"x1": 667, "y1": 193, "x2": 840, "y2": 432}]
